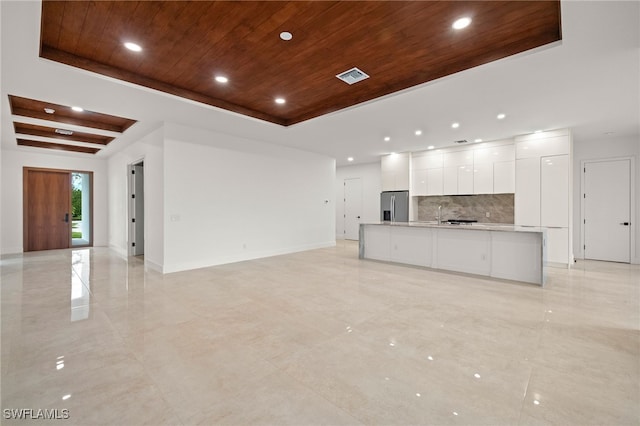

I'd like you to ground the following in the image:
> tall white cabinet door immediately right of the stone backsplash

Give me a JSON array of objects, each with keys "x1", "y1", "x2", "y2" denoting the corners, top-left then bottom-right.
[{"x1": 514, "y1": 158, "x2": 540, "y2": 226}]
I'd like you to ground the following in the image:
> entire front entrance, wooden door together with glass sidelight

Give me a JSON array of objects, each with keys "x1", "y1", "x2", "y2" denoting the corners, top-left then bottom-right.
[{"x1": 22, "y1": 167, "x2": 93, "y2": 252}]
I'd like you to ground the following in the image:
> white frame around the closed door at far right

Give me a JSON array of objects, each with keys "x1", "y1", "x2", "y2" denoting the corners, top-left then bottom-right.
[{"x1": 580, "y1": 156, "x2": 638, "y2": 264}]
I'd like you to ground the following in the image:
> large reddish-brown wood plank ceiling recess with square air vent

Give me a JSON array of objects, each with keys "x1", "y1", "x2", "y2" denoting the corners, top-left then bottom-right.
[{"x1": 40, "y1": 0, "x2": 561, "y2": 126}]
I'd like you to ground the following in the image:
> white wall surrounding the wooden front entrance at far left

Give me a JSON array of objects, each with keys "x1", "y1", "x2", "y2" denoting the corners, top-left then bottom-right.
[{"x1": 0, "y1": 149, "x2": 107, "y2": 254}]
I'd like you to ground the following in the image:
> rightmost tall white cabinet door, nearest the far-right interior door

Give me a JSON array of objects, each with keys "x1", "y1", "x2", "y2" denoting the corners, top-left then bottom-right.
[{"x1": 540, "y1": 155, "x2": 569, "y2": 228}]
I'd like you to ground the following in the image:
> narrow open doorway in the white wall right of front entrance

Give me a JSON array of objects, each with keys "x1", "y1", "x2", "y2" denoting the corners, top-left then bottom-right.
[{"x1": 128, "y1": 160, "x2": 144, "y2": 256}]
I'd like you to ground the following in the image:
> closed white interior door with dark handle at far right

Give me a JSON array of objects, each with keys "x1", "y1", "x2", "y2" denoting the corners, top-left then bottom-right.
[{"x1": 583, "y1": 159, "x2": 631, "y2": 263}]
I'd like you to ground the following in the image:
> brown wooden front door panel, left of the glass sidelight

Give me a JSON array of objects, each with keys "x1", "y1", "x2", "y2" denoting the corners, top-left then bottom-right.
[{"x1": 24, "y1": 168, "x2": 71, "y2": 251}]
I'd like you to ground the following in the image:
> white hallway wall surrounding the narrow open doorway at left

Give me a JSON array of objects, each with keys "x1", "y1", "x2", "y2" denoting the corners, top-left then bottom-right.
[{"x1": 109, "y1": 128, "x2": 164, "y2": 270}]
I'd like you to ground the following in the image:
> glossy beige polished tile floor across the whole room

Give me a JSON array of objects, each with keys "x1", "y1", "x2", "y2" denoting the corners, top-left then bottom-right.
[{"x1": 1, "y1": 241, "x2": 640, "y2": 425}]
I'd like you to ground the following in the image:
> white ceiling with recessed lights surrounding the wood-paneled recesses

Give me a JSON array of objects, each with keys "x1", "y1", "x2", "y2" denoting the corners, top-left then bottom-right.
[{"x1": 0, "y1": 1, "x2": 640, "y2": 165}]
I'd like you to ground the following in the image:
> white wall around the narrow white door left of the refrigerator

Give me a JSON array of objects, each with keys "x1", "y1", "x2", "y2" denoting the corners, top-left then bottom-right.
[{"x1": 335, "y1": 162, "x2": 382, "y2": 239}]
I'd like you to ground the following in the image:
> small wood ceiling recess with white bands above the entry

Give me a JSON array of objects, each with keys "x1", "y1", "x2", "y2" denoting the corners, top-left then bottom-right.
[{"x1": 9, "y1": 95, "x2": 136, "y2": 154}]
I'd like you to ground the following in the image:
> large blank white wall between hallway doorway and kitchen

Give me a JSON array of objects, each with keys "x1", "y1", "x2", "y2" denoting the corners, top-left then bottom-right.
[{"x1": 160, "y1": 123, "x2": 335, "y2": 272}]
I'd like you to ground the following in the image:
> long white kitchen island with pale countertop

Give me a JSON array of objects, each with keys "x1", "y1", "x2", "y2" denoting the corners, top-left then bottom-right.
[{"x1": 360, "y1": 222, "x2": 546, "y2": 286}]
